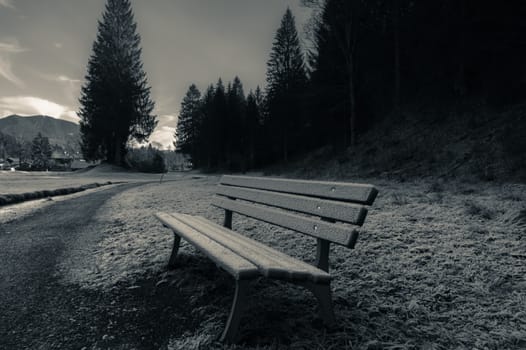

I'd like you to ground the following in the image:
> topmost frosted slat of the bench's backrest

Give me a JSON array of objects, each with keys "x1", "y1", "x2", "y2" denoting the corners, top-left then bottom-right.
[{"x1": 220, "y1": 175, "x2": 378, "y2": 205}]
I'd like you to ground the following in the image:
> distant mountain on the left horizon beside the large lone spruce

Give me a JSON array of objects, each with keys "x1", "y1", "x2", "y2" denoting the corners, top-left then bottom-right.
[{"x1": 0, "y1": 115, "x2": 80, "y2": 148}]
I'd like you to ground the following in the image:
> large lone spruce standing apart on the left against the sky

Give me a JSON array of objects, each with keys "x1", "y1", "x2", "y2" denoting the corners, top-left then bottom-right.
[{"x1": 79, "y1": 0, "x2": 157, "y2": 165}]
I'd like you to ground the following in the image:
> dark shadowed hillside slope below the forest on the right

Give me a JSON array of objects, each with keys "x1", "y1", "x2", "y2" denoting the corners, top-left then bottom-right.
[{"x1": 266, "y1": 106, "x2": 526, "y2": 181}]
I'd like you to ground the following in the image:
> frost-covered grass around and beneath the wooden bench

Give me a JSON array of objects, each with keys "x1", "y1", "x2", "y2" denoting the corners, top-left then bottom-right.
[{"x1": 57, "y1": 176, "x2": 526, "y2": 349}]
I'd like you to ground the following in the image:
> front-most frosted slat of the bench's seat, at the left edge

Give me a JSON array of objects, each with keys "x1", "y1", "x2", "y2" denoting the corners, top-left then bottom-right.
[{"x1": 155, "y1": 212, "x2": 260, "y2": 280}]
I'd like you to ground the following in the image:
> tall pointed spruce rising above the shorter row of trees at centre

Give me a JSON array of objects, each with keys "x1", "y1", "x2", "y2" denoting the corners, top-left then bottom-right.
[{"x1": 267, "y1": 8, "x2": 307, "y2": 161}]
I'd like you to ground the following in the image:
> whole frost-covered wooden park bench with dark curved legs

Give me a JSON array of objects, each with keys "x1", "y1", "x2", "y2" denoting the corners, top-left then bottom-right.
[{"x1": 156, "y1": 176, "x2": 378, "y2": 342}]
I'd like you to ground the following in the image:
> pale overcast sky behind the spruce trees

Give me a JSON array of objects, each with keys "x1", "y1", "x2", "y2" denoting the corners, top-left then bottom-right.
[{"x1": 0, "y1": 0, "x2": 308, "y2": 145}]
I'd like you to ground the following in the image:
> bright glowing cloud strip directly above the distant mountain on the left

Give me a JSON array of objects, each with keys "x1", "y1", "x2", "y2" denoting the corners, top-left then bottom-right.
[{"x1": 0, "y1": 96, "x2": 79, "y2": 123}]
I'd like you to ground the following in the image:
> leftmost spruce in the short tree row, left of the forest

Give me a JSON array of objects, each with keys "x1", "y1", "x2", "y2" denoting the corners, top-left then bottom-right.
[{"x1": 175, "y1": 84, "x2": 202, "y2": 158}]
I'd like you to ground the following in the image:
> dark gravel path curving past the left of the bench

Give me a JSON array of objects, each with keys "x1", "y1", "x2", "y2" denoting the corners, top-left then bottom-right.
[{"x1": 0, "y1": 184, "x2": 194, "y2": 349}]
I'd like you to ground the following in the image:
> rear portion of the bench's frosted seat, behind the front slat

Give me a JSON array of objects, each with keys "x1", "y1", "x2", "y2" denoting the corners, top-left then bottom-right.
[{"x1": 172, "y1": 214, "x2": 330, "y2": 283}]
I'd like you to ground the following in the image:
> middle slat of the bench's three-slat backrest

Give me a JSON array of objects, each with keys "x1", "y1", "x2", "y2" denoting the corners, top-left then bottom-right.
[{"x1": 216, "y1": 185, "x2": 367, "y2": 226}]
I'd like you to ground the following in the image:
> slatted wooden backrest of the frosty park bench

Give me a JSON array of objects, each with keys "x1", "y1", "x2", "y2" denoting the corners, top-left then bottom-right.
[{"x1": 212, "y1": 175, "x2": 378, "y2": 248}]
